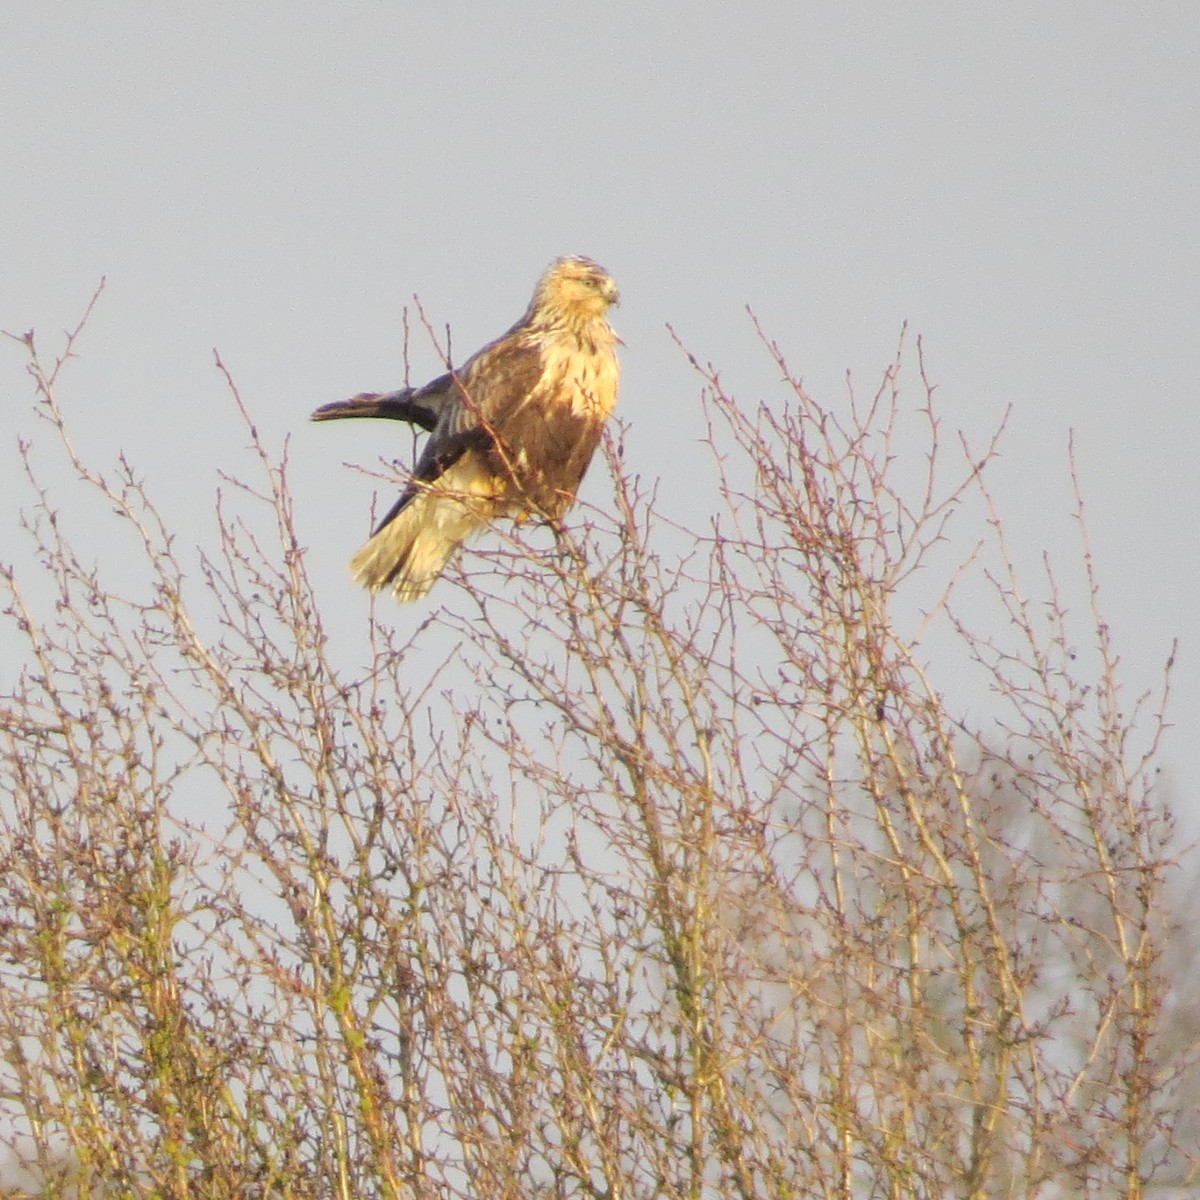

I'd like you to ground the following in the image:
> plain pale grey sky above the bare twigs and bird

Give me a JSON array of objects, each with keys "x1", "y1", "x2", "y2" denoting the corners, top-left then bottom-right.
[{"x1": 0, "y1": 0, "x2": 1200, "y2": 804}]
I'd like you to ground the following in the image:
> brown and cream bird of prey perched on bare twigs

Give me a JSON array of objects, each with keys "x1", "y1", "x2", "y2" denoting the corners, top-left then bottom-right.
[{"x1": 312, "y1": 257, "x2": 619, "y2": 600}]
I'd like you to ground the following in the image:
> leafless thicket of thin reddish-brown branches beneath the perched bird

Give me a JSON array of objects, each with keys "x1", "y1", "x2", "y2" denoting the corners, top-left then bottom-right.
[{"x1": 0, "y1": 292, "x2": 1196, "y2": 1200}]
